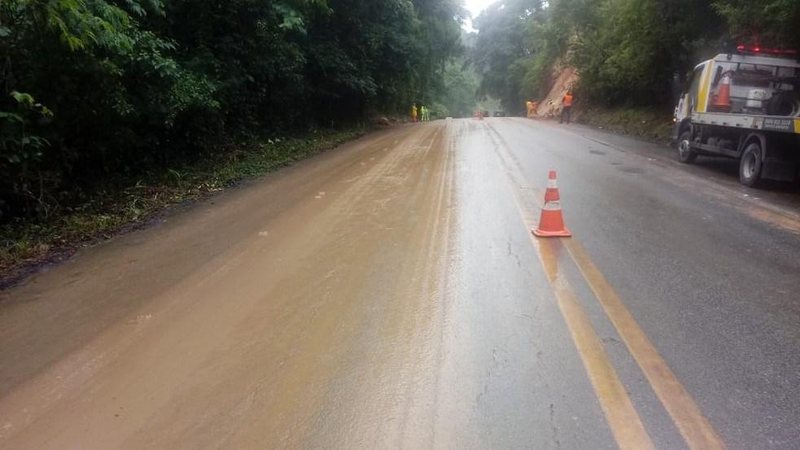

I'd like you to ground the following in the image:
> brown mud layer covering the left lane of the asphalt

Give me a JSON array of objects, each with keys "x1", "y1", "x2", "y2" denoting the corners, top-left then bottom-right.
[{"x1": 0, "y1": 122, "x2": 452, "y2": 448}]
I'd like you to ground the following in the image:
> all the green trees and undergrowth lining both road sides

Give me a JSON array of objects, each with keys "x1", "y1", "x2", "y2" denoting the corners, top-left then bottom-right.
[{"x1": 0, "y1": 0, "x2": 800, "y2": 280}]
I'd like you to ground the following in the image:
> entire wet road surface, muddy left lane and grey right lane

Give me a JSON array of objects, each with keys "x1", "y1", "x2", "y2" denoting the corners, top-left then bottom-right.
[{"x1": 0, "y1": 118, "x2": 800, "y2": 449}]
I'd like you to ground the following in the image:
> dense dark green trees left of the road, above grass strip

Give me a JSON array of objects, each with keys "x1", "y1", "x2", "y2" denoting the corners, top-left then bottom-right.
[{"x1": 0, "y1": 0, "x2": 465, "y2": 221}]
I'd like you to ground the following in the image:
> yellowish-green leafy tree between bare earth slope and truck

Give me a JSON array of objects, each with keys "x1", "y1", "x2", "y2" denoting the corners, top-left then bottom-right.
[{"x1": 571, "y1": 0, "x2": 720, "y2": 105}]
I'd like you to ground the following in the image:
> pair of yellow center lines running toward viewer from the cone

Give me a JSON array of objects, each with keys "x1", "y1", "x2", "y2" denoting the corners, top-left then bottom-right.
[{"x1": 520, "y1": 210, "x2": 726, "y2": 450}]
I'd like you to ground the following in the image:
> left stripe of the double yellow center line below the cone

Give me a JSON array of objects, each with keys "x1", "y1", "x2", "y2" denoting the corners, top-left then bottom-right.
[{"x1": 532, "y1": 237, "x2": 655, "y2": 450}]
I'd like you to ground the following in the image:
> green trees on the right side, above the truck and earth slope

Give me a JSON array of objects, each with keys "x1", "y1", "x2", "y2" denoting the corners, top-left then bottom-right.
[{"x1": 472, "y1": 0, "x2": 800, "y2": 110}]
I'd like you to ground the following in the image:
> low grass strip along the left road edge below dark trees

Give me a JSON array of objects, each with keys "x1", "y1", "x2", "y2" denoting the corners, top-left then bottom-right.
[{"x1": 0, "y1": 128, "x2": 365, "y2": 287}]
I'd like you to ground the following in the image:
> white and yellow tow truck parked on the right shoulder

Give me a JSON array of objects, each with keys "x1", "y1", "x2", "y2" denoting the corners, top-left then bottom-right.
[{"x1": 673, "y1": 45, "x2": 800, "y2": 187}]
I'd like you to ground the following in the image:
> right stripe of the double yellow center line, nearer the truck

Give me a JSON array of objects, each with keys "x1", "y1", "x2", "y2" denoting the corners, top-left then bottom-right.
[{"x1": 564, "y1": 239, "x2": 725, "y2": 449}]
